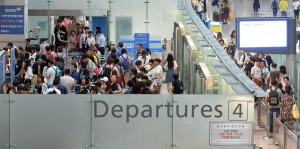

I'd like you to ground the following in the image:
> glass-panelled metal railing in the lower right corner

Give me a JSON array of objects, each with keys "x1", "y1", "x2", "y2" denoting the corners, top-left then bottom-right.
[{"x1": 257, "y1": 99, "x2": 300, "y2": 149}]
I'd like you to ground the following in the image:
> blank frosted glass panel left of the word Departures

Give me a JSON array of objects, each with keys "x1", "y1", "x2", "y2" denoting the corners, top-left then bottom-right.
[{"x1": 9, "y1": 94, "x2": 92, "y2": 149}]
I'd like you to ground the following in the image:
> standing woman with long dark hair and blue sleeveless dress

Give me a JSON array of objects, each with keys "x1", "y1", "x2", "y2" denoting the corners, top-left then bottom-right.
[{"x1": 164, "y1": 53, "x2": 178, "y2": 94}]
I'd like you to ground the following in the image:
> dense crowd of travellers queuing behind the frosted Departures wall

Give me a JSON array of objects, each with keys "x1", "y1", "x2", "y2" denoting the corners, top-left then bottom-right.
[{"x1": 3, "y1": 39, "x2": 183, "y2": 94}]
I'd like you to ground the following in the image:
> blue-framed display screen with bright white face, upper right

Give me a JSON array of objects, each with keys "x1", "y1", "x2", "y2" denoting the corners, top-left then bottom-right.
[{"x1": 236, "y1": 18, "x2": 290, "y2": 53}]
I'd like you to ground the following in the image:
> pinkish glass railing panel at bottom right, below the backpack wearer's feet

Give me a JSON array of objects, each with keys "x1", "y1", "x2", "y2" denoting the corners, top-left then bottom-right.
[{"x1": 273, "y1": 118, "x2": 284, "y2": 148}]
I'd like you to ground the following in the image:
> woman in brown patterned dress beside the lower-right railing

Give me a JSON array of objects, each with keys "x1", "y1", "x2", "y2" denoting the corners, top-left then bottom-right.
[{"x1": 280, "y1": 85, "x2": 295, "y2": 130}]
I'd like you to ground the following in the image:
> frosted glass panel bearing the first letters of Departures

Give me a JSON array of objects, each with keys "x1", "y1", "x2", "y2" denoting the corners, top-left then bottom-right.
[{"x1": 92, "y1": 95, "x2": 172, "y2": 149}]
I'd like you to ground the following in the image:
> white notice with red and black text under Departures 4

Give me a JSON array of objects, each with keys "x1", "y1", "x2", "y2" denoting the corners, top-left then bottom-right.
[{"x1": 209, "y1": 122, "x2": 252, "y2": 145}]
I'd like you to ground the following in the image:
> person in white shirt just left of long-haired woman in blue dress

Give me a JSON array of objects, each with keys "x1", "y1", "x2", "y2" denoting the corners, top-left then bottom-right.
[{"x1": 151, "y1": 58, "x2": 163, "y2": 94}]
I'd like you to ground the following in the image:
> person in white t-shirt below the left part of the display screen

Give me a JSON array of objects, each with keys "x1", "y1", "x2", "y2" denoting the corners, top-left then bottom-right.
[{"x1": 251, "y1": 59, "x2": 264, "y2": 87}]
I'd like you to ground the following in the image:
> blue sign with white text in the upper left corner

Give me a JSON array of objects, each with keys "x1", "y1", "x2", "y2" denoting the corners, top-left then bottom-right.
[{"x1": 0, "y1": 6, "x2": 24, "y2": 34}]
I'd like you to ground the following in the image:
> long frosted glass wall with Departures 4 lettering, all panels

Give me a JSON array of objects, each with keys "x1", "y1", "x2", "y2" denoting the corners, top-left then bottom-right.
[{"x1": 0, "y1": 94, "x2": 254, "y2": 149}]
